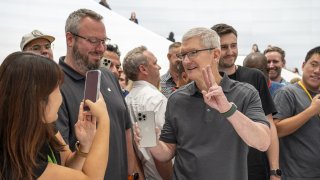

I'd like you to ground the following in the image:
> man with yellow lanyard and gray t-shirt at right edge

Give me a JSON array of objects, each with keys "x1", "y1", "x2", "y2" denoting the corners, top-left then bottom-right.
[{"x1": 273, "y1": 46, "x2": 320, "y2": 180}]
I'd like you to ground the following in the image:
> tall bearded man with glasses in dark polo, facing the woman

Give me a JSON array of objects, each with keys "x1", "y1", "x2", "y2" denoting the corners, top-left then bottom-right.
[{"x1": 57, "y1": 9, "x2": 139, "y2": 180}]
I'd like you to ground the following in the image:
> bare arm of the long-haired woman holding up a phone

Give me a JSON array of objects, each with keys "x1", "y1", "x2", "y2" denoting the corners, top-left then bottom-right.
[{"x1": 39, "y1": 96, "x2": 110, "y2": 179}]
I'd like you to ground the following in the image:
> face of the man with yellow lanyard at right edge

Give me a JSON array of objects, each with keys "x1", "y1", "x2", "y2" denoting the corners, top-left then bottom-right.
[{"x1": 302, "y1": 54, "x2": 320, "y2": 92}]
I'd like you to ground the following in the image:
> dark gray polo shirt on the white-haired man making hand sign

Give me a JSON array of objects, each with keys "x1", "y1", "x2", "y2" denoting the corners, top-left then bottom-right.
[{"x1": 160, "y1": 76, "x2": 269, "y2": 180}]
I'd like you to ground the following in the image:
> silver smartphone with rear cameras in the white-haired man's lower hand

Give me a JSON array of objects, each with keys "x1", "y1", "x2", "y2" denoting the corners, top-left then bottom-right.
[{"x1": 137, "y1": 111, "x2": 157, "y2": 147}]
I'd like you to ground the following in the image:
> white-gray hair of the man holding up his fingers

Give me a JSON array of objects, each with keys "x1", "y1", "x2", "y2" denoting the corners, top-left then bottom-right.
[{"x1": 182, "y1": 27, "x2": 220, "y2": 49}]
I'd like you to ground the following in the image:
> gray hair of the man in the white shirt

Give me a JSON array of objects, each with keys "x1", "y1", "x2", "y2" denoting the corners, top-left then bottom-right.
[{"x1": 123, "y1": 46, "x2": 148, "y2": 81}]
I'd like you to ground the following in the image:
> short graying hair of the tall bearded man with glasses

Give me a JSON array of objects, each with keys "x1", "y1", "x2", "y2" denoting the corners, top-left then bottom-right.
[{"x1": 65, "y1": 9, "x2": 103, "y2": 33}]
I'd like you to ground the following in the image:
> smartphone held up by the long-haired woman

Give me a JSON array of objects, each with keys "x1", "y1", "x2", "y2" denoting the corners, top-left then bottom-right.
[{"x1": 83, "y1": 70, "x2": 101, "y2": 111}]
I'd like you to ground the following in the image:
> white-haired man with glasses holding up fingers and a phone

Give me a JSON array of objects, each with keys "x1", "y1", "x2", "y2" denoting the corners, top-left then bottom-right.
[{"x1": 135, "y1": 28, "x2": 270, "y2": 180}]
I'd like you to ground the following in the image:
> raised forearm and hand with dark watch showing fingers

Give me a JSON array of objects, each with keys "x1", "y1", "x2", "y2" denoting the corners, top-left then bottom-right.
[{"x1": 202, "y1": 66, "x2": 270, "y2": 151}]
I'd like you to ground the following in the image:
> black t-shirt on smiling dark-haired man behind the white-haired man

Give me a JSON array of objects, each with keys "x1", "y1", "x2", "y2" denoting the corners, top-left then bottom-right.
[{"x1": 229, "y1": 66, "x2": 277, "y2": 180}]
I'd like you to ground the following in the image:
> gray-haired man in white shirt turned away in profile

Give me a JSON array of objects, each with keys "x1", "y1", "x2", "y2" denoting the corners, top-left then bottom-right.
[{"x1": 123, "y1": 46, "x2": 172, "y2": 180}]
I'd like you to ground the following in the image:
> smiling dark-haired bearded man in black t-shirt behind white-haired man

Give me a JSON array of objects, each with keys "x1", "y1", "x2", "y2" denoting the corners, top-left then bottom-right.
[{"x1": 211, "y1": 24, "x2": 279, "y2": 180}]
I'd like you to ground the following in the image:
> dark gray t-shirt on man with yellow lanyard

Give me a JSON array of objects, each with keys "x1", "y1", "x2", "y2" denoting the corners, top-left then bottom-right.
[{"x1": 273, "y1": 83, "x2": 320, "y2": 180}]
